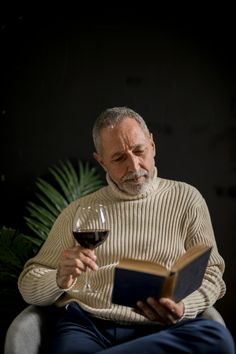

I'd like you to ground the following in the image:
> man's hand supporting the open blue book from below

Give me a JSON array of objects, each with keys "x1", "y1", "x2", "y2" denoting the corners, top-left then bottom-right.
[{"x1": 134, "y1": 297, "x2": 184, "y2": 324}]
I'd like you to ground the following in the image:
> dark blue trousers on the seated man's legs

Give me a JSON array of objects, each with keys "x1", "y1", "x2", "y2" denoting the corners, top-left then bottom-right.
[{"x1": 52, "y1": 303, "x2": 235, "y2": 354}]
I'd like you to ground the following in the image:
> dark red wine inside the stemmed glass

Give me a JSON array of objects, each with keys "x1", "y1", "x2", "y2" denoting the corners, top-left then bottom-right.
[{"x1": 73, "y1": 230, "x2": 109, "y2": 249}]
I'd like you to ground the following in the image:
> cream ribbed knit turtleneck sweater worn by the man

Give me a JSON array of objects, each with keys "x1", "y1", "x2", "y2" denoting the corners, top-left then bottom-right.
[{"x1": 18, "y1": 171, "x2": 225, "y2": 323}]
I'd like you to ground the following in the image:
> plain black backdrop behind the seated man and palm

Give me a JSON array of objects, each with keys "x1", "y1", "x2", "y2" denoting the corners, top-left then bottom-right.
[{"x1": 0, "y1": 4, "x2": 236, "y2": 352}]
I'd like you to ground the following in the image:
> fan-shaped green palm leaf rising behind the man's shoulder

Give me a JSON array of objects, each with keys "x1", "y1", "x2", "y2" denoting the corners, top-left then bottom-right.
[{"x1": 24, "y1": 160, "x2": 102, "y2": 246}]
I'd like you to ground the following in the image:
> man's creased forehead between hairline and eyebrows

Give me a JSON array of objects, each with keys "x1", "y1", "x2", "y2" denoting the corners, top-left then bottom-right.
[{"x1": 100, "y1": 118, "x2": 148, "y2": 154}]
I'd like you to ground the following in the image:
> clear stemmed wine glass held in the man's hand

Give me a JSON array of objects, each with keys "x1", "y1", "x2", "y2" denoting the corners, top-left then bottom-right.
[{"x1": 72, "y1": 204, "x2": 109, "y2": 293}]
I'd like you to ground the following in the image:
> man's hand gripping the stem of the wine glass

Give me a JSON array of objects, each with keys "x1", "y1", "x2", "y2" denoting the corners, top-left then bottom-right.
[{"x1": 57, "y1": 245, "x2": 98, "y2": 289}]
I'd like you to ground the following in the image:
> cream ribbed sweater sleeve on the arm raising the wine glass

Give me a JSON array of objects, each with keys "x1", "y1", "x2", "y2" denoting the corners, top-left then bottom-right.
[{"x1": 18, "y1": 203, "x2": 78, "y2": 306}]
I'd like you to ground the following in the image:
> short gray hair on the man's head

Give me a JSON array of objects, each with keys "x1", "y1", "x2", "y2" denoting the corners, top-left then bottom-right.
[{"x1": 92, "y1": 107, "x2": 150, "y2": 152}]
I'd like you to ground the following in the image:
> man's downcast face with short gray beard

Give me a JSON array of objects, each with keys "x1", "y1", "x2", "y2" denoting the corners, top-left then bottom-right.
[{"x1": 94, "y1": 118, "x2": 155, "y2": 195}]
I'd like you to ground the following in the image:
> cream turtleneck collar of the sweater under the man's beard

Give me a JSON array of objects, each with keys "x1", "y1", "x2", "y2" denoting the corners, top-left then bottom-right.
[{"x1": 106, "y1": 167, "x2": 159, "y2": 200}]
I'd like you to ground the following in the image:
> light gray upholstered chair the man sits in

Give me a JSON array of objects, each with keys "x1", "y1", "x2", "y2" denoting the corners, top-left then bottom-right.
[{"x1": 4, "y1": 305, "x2": 225, "y2": 354}]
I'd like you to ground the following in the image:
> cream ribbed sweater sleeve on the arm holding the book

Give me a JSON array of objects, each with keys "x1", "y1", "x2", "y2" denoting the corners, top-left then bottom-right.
[{"x1": 183, "y1": 198, "x2": 226, "y2": 318}]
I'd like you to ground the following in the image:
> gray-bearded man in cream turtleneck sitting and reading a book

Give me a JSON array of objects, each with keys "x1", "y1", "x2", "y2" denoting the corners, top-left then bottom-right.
[{"x1": 19, "y1": 107, "x2": 234, "y2": 354}]
